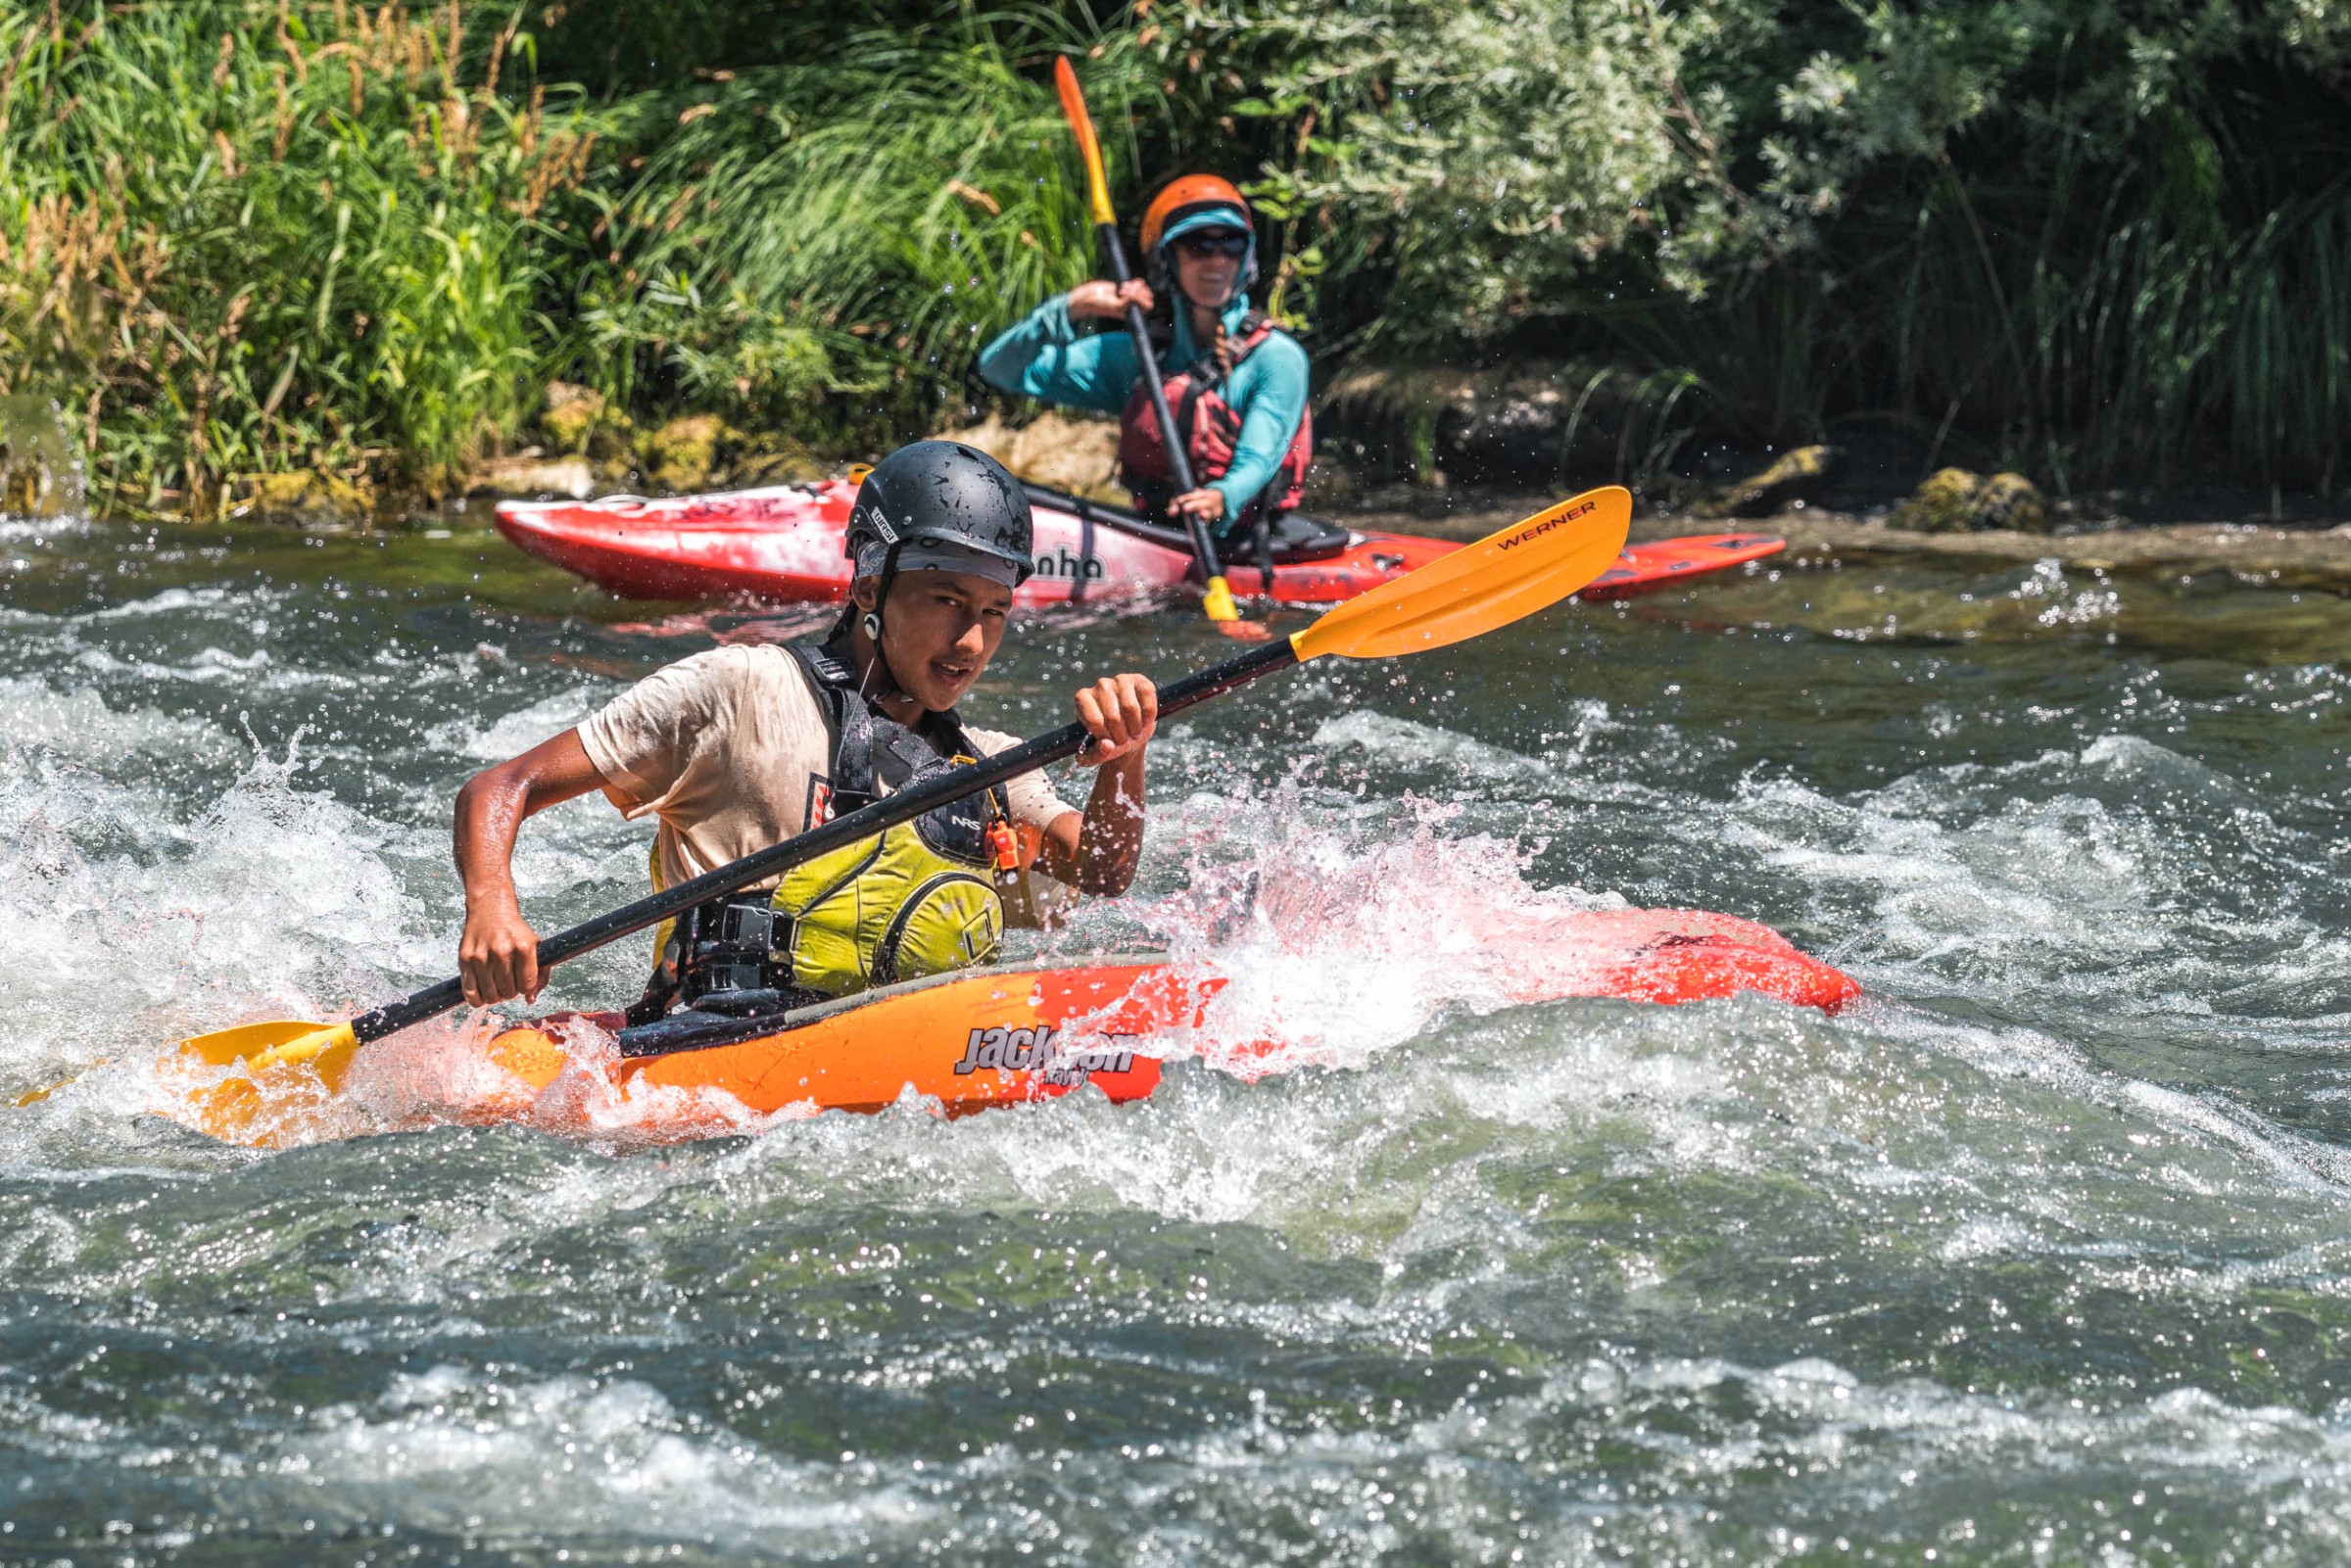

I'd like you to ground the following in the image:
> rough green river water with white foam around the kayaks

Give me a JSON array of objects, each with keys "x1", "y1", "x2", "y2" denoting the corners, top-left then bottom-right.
[{"x1": 0, "y1": 509, "x2": 2351, "y2": 1563}]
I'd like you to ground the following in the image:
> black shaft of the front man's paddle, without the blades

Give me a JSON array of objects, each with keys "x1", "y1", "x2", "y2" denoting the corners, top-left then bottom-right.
[{"x1": 351, "y1": 637, "x2": 1298, "y2": 1041}]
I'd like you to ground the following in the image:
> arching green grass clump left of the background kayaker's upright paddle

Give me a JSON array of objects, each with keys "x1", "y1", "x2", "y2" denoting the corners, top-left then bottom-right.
[{"x1": 578, "y1": 5, "x2": 1154, "y2": 442}]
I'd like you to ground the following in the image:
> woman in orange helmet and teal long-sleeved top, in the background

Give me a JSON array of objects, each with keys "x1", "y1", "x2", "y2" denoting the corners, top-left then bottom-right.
[{"x1": 981, "y1": 174, "x2": 1315, "y2": 554}]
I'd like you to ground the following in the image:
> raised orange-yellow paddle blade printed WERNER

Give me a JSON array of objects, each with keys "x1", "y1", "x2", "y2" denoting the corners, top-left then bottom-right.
[{"x1": 1291, "y1": 484, "x2": 1632, "y2": 663}]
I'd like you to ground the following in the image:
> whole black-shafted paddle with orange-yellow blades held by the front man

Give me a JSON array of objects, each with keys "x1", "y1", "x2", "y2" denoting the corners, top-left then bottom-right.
[{"x1": 36, "y1": 484, "x2": 1632, "y2": 1138}]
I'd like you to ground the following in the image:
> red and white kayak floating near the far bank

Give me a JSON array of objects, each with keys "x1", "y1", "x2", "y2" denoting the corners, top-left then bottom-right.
[{"x1": 496, "y1": 480, "x2": 1785, "y2": 604}]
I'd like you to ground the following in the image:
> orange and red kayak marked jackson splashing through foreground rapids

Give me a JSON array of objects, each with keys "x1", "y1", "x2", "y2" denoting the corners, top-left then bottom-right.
[{"x1": 158, "y1": 910, "x2": 1859, "y2": 1145}]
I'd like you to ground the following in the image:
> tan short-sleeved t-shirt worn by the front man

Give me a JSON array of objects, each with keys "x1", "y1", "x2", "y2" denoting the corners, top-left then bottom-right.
[{"x1": 578, "y1": 644, "x2": 1070, "y2": 886}]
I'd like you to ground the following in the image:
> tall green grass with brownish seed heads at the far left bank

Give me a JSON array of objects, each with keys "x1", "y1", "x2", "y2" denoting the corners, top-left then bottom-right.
[{"x1": 0, "y1": 0, "x2": 595, "y2": 517}]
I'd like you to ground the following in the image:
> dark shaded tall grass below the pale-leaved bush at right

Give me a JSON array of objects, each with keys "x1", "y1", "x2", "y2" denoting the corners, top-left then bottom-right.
[{"x1": 1585, "y1": 96, "x2": 2351, "y2": 494}]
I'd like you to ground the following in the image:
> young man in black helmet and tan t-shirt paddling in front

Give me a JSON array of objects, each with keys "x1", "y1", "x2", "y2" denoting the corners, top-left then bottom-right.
[{"x1": 456, "y1": 442, "x2": 1159, "y2": 1025}]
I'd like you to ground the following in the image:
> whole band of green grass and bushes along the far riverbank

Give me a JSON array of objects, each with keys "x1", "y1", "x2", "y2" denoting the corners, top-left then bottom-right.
[{"x1": 0, "y1": 0, "x2": 2351, "y2": 517}]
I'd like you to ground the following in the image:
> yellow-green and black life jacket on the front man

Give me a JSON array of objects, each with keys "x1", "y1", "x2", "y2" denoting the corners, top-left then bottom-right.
[{"x1": 630, "y1": 644, "x2": 1023, "y2": 1022}]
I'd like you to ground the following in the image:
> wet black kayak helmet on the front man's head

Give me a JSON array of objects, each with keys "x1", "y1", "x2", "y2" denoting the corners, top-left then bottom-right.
[{"x1": 841, "y1": 442, "x2": 1036, "y2": 597}]
